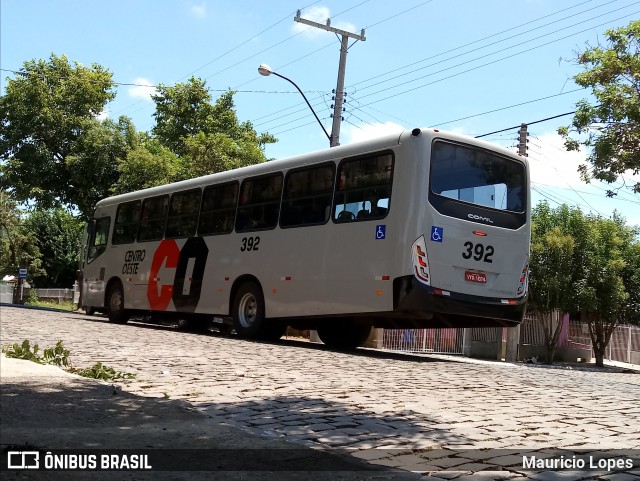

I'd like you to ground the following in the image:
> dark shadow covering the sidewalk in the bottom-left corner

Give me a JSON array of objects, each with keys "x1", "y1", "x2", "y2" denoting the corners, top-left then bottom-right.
[{"x1": 0, "y1": 376, "x2": 410, "y2": 472}]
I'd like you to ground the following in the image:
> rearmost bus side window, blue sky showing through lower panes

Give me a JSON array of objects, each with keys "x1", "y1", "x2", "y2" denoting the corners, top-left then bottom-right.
[{"x1": 333, "y1": 153, "x2": 393, "y2": 223}]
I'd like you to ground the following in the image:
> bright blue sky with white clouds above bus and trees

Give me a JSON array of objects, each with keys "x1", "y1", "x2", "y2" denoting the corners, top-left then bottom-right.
[{"x1": 0, "y1": 0, "x2": 640, "y2": 225}]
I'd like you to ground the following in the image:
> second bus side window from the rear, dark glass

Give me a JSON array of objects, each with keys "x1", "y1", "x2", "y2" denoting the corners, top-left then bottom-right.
[{"x1": 280, "y1": 163, "x2": 335, "y2": 227}]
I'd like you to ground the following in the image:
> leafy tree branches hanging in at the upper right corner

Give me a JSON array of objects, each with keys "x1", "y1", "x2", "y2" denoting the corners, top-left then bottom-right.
[{"x1": 558, "y1": 20, "x2": 640, "y2": 196}]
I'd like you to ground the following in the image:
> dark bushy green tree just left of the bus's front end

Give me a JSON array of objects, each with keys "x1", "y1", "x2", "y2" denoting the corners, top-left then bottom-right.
[{"x1": 24, "y1": 207, "x2": 84, "y2": 288}]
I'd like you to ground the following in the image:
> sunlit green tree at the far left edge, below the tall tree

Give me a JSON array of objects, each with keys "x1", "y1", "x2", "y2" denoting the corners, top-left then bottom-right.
[{"x1": 0, "y1": 192, "x2": 44, "y2": 278}]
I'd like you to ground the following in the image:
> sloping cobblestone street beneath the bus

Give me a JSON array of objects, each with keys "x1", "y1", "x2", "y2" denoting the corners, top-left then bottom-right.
[{"x1": 0, "y1": 307, "x2": 640, "y2": 481}]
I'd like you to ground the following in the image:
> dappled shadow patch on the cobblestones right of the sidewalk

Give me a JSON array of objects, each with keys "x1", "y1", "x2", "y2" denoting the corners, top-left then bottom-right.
[{"x1": 193, "y1": 394, "x2": 473, "y2": 454}]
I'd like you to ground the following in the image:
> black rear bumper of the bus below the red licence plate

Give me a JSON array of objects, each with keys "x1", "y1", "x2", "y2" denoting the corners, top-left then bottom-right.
[{"x1": 393, "y1": 276, "x2": 527, "y2": 327}]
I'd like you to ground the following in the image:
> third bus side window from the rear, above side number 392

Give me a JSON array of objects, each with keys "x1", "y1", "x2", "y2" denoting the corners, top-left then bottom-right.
[{"x1": 236, "y1": 172, "x2": 282, "y2": 232}]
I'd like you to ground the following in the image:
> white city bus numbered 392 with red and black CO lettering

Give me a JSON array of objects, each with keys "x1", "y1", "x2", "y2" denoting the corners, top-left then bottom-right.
[{"x1": 83, "y1": 129, "x2": 530, "y2": 348}]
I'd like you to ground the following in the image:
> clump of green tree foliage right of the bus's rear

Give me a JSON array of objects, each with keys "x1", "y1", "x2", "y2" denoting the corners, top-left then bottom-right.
[{"x1": 530, "y1": 203, "x2": 640, "y2": 365}]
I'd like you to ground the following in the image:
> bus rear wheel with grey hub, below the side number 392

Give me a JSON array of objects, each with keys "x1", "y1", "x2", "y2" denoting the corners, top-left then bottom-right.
[{"x1": 231, "y1": 282, "x2": 287, "y2": 341}]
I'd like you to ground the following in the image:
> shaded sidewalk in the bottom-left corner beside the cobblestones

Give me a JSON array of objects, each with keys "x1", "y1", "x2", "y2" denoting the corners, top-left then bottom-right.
[{"x1": 0, "y1": 354, "x2": 420, "y2": 481}]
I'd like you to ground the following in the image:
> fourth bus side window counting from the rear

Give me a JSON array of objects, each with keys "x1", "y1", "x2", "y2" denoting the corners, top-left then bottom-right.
[{"x1": 198, "y1": 182, "x2": 238, "y2": 236}]
